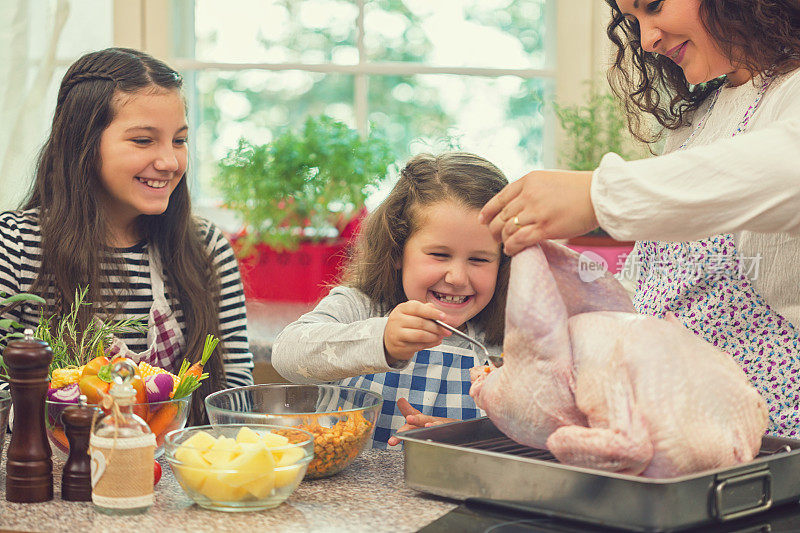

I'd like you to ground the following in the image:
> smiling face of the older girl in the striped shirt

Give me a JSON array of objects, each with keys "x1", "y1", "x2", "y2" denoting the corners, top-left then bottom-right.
[{"x1": 100, "y1": 90, "x2": 189, "y2": 246}]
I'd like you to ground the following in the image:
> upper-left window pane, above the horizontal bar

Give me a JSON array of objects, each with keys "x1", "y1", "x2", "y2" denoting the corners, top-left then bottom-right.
[{"x1": 195, "y1": 0, "x2": 358, "y2": 64}]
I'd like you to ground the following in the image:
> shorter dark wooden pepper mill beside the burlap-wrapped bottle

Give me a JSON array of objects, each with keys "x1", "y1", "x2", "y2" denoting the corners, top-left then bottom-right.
[{"x1": 61, "y1": 395, "x2": 95, "y2": 502}]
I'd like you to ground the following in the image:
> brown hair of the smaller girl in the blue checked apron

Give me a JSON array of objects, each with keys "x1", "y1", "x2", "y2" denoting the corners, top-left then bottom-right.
[{"x1": 343, "y1": 152, "x2": 510, "y2": 344}]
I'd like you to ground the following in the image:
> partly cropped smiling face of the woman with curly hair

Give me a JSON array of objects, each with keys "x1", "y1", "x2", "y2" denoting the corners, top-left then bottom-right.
[{"x1": 617, "y1": 0, "x2": 750, "y2": 85}]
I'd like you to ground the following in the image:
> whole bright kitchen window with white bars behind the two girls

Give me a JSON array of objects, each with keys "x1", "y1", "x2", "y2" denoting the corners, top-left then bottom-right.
[{"x1": 170, "y1": 0, "x2": 556, "y2": 227}]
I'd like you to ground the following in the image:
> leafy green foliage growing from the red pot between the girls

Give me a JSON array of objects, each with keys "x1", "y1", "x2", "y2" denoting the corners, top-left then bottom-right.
[{"x1": 216, "y1": 115, "x2": 395, "y2": 253}]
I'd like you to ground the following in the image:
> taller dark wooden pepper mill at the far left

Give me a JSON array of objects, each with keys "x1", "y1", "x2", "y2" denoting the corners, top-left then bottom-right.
[{"x1": 3, "y1": 329, "x2": 53, "y2": 503}]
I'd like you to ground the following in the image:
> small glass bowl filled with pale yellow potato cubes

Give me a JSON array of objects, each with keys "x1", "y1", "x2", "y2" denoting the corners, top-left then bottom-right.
[{"x1": 164, "y1": 424, "x2": 314, "y2": 512}]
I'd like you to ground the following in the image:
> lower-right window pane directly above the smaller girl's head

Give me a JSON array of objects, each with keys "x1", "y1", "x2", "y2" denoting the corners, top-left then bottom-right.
[{"x1": 369, "y1": 75, "x2": 552, "y2": 180}]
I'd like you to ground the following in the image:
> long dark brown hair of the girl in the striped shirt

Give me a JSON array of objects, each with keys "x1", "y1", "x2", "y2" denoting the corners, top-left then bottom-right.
[{"x1": 24, "y1": 48, "x2": 224, "y2": 422}]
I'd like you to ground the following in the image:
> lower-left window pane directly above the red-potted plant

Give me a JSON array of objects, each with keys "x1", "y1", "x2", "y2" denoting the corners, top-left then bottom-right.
[{"x1": 191, "y1": 70, "x2": 354, "y2": 197}]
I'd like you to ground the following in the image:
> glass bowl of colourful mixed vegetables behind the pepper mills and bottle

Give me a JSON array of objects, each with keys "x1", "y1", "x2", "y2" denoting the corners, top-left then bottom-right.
[{"x1": 45, "y1": 335, "x2": 219, "y2": 457}]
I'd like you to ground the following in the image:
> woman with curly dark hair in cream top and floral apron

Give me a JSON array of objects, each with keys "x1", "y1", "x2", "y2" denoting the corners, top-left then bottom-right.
[{"x1": 481, "y1": 0, "x2": 800, "y2": 436}]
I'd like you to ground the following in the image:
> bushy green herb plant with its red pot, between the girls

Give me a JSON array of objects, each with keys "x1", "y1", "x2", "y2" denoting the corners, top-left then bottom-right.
[{"x1": 216, "y1": 115, "x2": 394, "y2": 302}]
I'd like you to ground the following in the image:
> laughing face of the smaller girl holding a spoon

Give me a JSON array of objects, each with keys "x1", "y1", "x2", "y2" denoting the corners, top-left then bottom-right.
[{"x1": 402, "y1": 202, "x2": 500, "y2": 327}]
